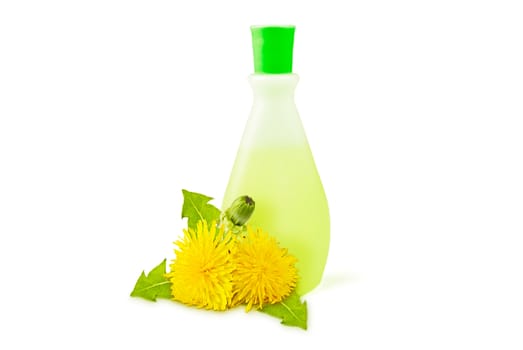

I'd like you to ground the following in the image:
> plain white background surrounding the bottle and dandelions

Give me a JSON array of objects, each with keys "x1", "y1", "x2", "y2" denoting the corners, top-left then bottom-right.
[{"x1": 0, "y1": 0, "x2": 523, "y2": 349}]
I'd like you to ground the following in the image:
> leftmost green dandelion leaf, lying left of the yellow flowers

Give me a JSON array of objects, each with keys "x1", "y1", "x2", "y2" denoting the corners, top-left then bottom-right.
[{"x1": 131, "y1": 259, "x2": 171, "y2": 301}]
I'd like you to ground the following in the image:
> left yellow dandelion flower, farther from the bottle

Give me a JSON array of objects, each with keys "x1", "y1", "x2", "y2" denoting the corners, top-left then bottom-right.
[{"x1": 167, "y1": 221, "x2": 234, "y2": 310}]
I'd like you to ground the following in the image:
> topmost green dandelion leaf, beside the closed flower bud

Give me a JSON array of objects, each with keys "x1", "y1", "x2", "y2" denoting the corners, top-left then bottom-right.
[{"x1": 182, "y1": 190, "x2": 221, "y2": 229}]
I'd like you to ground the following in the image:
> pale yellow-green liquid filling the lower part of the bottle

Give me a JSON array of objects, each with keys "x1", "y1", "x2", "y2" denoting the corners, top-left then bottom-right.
[{"x1": 223, "y1": 143, "x2": 330, "y2": 295}]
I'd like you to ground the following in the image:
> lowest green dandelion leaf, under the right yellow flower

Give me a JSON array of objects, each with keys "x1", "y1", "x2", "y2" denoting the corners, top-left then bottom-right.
[{"x1": 259, "y1": 292, "x2": 307, "y2": 329}]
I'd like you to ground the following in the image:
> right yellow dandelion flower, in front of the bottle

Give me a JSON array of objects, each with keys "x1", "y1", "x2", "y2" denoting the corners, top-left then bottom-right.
[{"x1": 232, "y1": 227, "x2": 298, "y2": 311}]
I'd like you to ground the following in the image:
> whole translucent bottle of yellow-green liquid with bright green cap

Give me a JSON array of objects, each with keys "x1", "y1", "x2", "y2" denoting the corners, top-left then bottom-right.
[{"x1": 222, "y1": 26, "x2": 330, "y2": 295}]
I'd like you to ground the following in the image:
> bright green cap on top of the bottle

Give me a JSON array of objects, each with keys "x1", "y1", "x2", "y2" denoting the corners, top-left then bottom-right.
[{"x1": 251, "y1": 26, "x2": 295, "y2": 74}]
